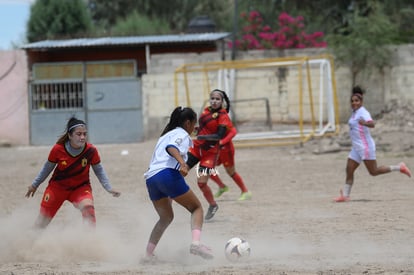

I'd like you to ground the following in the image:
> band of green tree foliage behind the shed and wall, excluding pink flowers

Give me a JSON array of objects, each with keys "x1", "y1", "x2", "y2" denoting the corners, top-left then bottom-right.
[{"x1": 27, "y1": 0, "x2": 414, "y2": 85}]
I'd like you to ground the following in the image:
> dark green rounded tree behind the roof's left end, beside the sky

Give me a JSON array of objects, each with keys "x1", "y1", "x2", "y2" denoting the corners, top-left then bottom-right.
[{"x1": 27, "y1": 0, "x2": 91, "y2": 42}]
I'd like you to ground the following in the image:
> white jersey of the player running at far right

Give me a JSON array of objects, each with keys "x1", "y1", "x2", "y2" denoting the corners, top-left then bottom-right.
[{"x1": 348, "y1": 106, "x2": 375, "y2": 152}]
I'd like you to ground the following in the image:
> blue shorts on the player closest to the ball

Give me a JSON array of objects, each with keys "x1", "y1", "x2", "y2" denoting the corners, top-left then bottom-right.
[{"x1": 146, "y1": 168, "x2": 190, "y2": 201}]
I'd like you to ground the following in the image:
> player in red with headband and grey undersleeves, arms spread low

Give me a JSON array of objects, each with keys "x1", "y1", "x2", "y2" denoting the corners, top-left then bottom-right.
[{"x1": 26, "y1": 117, "x2": 121, "y2": 228}]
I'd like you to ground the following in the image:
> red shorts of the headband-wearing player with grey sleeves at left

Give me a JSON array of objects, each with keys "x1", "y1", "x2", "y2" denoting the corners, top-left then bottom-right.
[{"x1": 40, "y1": 184, "x2": 93, "y2": 218}]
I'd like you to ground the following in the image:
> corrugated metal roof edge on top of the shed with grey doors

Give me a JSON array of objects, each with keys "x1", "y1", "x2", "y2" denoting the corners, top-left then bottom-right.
[{"x1": 21, "y1": 32, "x2": 230, "y2": 49}]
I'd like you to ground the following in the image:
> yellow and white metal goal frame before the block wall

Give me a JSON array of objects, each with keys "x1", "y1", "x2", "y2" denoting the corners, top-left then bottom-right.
[{"x1": 174, "y1": 55, "x2": 339, "y2": 147}]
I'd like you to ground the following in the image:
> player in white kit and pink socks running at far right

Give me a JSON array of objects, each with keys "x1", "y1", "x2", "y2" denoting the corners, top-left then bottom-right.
[{"x1": 334, "y1": 86, "x2": 411, "y2": 202}]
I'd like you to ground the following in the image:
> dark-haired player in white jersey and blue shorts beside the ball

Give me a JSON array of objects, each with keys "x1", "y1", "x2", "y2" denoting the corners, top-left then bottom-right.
[{"x1": 144, "y1": 107, "x2": 213, "y2": 259}]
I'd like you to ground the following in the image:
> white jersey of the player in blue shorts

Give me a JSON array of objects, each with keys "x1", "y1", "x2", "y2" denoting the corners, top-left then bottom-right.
[{"x1": 144, "y1": 127, "x2": 193, "y2": 179}]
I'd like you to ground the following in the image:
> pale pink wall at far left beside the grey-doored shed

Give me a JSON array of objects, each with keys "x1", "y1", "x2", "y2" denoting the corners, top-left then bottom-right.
[{"x1": 0, "y1": 51, "x2": 29, "y2": 145}]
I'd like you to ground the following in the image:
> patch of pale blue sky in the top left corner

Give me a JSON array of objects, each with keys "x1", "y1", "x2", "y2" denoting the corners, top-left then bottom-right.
[{"x1": 0, "y1": 0, "x2": 34, "y2": 50}]
